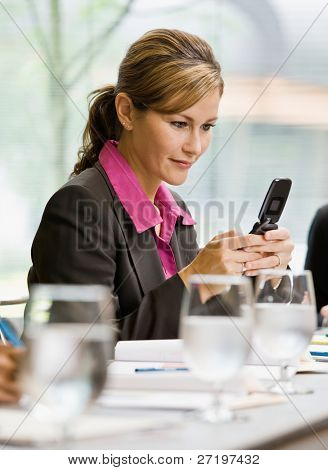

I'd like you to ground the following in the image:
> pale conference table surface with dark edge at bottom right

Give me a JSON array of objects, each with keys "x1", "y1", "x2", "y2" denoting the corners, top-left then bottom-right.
[{"x1": 40, "y1": 373, "x2": 328, "y2": 450}]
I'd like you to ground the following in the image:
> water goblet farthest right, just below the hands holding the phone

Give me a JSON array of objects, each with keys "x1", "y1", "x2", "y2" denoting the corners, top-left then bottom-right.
[{"x1": 254, "y1": 269, "x2": 317, "y2": 394}]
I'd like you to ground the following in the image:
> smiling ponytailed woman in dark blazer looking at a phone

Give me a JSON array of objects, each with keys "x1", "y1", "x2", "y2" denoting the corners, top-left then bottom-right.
[{"x1": 28, "y1": 29, "x2": 293, "y2": 339}]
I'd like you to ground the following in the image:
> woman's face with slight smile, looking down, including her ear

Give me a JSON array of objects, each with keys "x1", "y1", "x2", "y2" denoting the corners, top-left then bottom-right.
[{"x1": 125, "y1": 89, "x2": 220, "y2": 185}]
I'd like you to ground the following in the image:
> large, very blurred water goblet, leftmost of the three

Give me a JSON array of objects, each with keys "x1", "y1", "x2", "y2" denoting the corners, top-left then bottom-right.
[{"x1": 21, "y1": 284, "x2": 115, "y2": 439}]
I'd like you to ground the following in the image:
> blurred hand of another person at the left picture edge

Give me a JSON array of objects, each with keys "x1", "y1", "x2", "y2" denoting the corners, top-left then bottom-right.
[{"x1": 0, "y1": 345, "x2": 24, "y2": 403}]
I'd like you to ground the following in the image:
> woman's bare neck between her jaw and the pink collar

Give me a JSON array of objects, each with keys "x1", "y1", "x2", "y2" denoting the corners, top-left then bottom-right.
[{"x1": 117, "y1": 136, "x2": 161, "y2": 204}]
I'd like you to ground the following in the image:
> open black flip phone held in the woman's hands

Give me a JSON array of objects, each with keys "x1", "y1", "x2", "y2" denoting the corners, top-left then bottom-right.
[{"x1": 249, "y1": 178, "x2": 292, "y2": 235}]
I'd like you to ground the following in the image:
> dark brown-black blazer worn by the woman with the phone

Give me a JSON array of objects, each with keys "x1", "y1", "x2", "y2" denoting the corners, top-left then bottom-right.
[{"x1": 28, "y1": 163, "x2": 198, "y2": 340}]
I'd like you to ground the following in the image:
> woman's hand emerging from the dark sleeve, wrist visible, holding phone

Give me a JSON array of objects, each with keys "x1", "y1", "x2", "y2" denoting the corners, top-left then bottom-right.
[{"x1": 179, "y1": 230, "x2": 268, "y2": 286}]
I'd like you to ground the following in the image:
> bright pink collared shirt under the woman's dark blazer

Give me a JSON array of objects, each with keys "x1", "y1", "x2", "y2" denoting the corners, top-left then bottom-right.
[{"x1": 99, "y1": 140, "x2": 196, "y2": 279}]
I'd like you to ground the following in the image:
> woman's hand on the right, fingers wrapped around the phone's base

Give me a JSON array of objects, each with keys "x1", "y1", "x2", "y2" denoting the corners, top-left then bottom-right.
[{"x1": 244, "y1": 227, "x2": 294, "y2": 276}]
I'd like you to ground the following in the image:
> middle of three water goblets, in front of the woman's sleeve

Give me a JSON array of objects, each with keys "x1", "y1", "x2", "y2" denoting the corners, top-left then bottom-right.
[{"x1": 180, "y1": 274, "x2": 254, "y2": 422}]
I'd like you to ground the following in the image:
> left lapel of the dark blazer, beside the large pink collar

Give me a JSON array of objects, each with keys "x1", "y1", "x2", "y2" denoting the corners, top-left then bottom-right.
[{"x1": 95, "y1": 163, "x2": 165, "y2": 295}]
